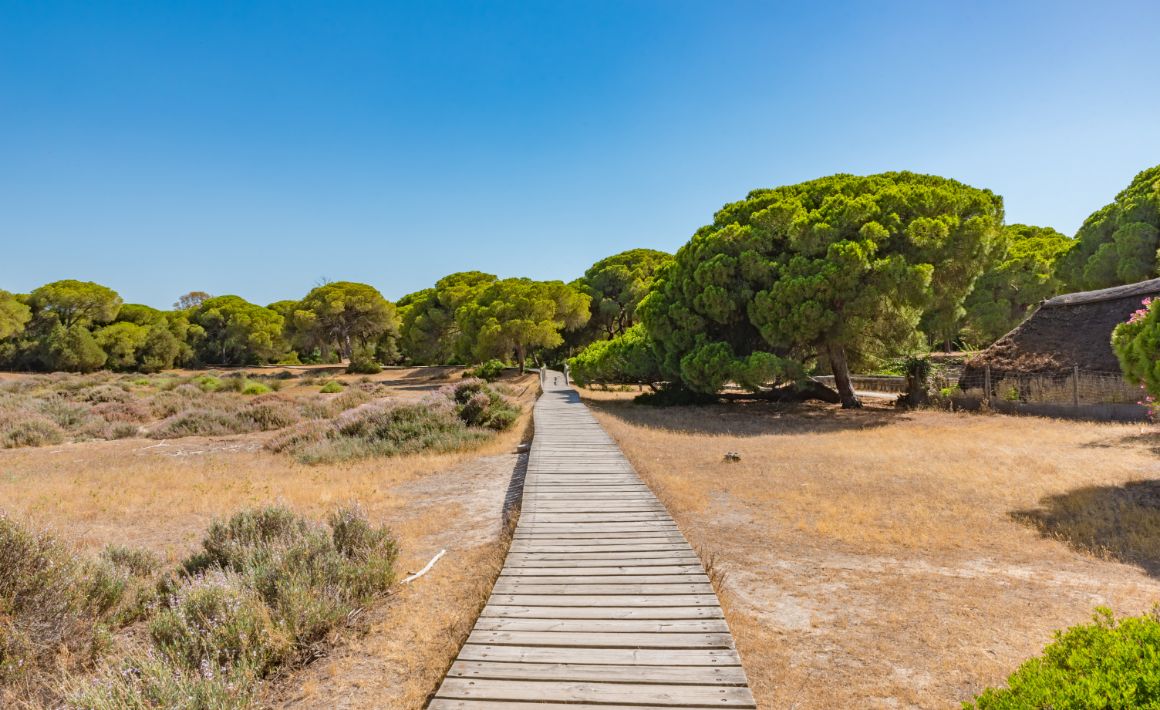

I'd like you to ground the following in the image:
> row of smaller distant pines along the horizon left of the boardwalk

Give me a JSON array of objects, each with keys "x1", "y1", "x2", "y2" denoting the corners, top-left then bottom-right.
[{"x1": 0, "y1": 271, "x2": 590, "y2": 372}]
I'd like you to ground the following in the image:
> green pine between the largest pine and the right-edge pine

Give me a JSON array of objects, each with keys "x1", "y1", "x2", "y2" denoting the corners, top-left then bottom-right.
[{"x1": 962, "y1": 224, "x2": 1075, "y2": 345}]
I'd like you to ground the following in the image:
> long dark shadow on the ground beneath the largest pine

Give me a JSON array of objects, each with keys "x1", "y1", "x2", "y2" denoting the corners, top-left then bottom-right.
[{"x1": 586, "y1": 399, "x2": 908, "y2": 436}]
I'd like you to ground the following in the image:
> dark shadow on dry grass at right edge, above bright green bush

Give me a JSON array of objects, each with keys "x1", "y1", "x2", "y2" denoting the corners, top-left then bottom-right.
[{"x1": 1009, "y1": 479, "x2": 1160, "y2": 577}]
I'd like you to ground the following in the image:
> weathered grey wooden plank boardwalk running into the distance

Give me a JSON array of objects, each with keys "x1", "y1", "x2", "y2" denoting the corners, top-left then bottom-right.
[{"x1": 428, "y1": 372, "x2": 756, "y2": 710}]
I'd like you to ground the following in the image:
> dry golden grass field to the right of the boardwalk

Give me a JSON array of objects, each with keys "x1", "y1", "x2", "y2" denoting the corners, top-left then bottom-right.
[{"x1": 586, "y1": 392, "x2": 1160, "y2": 708}]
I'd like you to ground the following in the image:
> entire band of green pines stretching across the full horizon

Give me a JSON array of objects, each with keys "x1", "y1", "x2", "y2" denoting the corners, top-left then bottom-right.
[{"x1": 0, "y1": 166, "x2": 1160, "y2": 406}]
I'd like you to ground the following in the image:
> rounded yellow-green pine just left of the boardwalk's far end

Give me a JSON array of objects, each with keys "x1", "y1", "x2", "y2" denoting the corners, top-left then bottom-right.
[{"x1": 456, "y1": 278, "x2": 590, "y2": 371}]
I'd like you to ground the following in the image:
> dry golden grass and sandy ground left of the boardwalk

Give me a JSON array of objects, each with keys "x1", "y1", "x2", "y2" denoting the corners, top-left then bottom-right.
[{"x1": 0, "y1": 370, "x2": 537, "y2": 708}]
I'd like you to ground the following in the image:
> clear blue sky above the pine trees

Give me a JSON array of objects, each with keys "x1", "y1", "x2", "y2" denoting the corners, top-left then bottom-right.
[{"x1": 0, "y1": 0, "x2": 1160, "y2": 306}]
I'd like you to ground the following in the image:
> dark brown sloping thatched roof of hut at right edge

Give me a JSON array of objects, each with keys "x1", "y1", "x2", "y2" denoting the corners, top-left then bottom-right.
[{"x1": 966, "y1": 278, "x2": 1160, "y2": 376}]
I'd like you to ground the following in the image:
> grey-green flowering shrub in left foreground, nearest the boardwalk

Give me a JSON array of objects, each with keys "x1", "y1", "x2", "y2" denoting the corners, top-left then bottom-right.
[{"x1": 68, "y1": 506, "x2": 398, "y2": 710}]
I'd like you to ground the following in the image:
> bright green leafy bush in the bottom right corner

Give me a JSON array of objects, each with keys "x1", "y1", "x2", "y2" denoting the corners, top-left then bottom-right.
[{"x1": 963, "y1": 607, "x2": 1160, "y2": 710}]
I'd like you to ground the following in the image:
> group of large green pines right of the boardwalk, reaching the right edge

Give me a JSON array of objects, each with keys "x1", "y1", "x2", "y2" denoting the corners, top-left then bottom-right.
[{"x1": 571, "y1": 166, "x2": 1160, "y2": 407}]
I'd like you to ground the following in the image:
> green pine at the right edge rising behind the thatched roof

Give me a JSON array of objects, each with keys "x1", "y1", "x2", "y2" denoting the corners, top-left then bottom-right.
[{"x1": 1059, "y1": 165, "x2": 1160, "y2": 291}]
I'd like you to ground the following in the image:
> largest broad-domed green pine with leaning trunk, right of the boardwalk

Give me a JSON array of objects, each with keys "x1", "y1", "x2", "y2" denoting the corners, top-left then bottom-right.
[{"x1": 638, "y1": 173, "x2": 1002, "y2": 407}]
